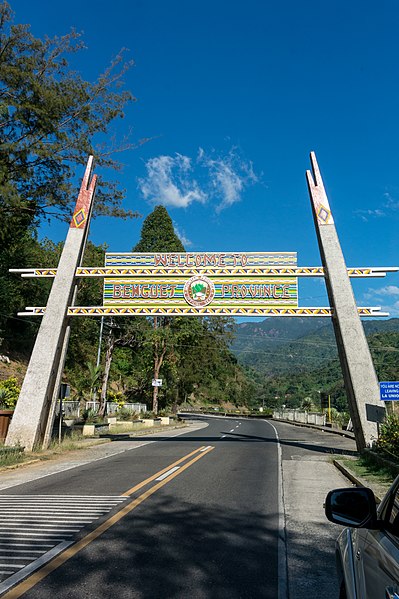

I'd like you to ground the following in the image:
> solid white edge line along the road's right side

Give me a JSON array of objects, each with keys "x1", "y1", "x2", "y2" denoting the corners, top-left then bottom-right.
[{"x1": 265, "y1": 421, "x2": 289, "y2": 599}]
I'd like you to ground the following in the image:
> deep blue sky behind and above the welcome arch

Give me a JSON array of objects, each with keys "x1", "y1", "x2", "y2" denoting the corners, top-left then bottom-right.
[{"x1": 10, "y1": 0, "x2": 399, "y2": 316}]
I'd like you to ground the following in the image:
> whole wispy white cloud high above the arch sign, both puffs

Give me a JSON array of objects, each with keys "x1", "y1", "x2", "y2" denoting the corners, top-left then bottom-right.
[{"x1": 138, "y1": 147, "x2": 259, "y2": 212}]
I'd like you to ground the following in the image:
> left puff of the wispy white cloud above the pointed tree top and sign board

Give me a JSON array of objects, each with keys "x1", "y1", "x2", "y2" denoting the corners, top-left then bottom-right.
[{"x1": 138, "y1": 154, "x2": 207, "y2": 208}]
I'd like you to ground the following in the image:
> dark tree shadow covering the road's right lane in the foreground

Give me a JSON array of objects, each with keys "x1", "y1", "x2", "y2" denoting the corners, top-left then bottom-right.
[{"x1": 18, "y1": 495, "x2": 333, "y2": 599}]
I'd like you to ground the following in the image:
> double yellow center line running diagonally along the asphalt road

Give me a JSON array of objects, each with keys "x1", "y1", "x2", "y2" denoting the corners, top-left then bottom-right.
[{"x1": 2, "y1": 447, "x2": 215, "y2": 599}]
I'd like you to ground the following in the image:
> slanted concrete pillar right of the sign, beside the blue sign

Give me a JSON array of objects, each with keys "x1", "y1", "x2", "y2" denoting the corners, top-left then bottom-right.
[{"x1": 306, "y1": 152, "x2": 384, "y2": 451}]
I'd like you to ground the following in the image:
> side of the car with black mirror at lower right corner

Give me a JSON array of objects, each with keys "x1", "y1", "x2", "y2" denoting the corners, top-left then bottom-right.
[{"x1": 325, "y1": 476, "x2": 399, "y2": 599}]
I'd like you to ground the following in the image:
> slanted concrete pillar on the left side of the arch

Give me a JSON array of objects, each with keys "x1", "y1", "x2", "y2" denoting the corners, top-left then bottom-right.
[{"x1": 5, "y1": 156, "x2": 96, "y2": 450}]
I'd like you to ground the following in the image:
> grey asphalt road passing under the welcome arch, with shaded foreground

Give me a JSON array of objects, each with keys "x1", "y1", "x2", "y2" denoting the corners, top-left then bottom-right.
[{"x1": 0, "y1": 418, "x2": 354, "y2": 599}]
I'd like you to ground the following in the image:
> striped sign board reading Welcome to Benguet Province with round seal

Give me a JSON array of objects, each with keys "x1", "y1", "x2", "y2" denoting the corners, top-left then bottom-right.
[{"x1": 103, "y1": 252, "x2": 298, "y2": 316}]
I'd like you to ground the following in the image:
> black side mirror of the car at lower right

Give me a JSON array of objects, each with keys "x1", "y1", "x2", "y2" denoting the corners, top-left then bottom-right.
[{"x1": 324, "y1": 487, "x2": 377, "y2": 528}]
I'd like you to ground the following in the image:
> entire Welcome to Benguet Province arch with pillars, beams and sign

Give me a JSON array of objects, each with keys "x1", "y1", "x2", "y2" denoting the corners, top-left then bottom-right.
[{"x1": 6, "y1": 152, "x2": 398, "y2": 450}]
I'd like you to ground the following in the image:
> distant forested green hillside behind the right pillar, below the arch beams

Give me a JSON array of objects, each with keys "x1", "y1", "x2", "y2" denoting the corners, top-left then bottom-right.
[{"x1": 238, "y1": 319, "x2": 399, "y2": 411}]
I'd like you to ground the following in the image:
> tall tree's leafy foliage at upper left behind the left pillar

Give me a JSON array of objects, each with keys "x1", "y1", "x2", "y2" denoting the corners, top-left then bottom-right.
[{"x1": 0, "y1": 1, "x2": 140, "y2": 351}]
